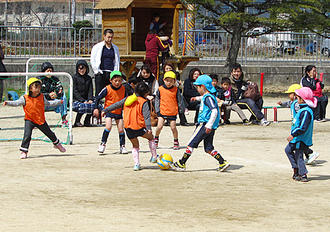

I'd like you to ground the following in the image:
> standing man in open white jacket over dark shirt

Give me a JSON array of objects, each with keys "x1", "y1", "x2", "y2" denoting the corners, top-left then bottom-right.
[{"x1": 91, "y1": 29, "x2": 120, "y2": 96}]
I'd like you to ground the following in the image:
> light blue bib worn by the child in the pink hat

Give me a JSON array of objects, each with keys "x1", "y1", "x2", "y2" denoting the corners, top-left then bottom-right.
[{"x1": 290, "y1": 104, "x2": 314, "y2": 148}]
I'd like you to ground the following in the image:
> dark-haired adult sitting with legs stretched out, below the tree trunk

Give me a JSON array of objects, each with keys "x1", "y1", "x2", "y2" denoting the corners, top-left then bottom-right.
[{"x1": 230, "y1": 63, "x2": 270, "y2": 126}]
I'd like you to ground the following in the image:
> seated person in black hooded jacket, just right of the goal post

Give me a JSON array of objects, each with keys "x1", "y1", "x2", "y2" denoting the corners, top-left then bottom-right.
[{"x1": 73, "y1": 60, "x2": 94, "y2": 127}]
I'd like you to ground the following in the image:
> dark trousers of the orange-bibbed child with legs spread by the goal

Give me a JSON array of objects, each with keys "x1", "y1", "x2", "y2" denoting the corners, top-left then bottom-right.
[{"x1": 20, "y1": 120, "x2": 60, "y2": 152}]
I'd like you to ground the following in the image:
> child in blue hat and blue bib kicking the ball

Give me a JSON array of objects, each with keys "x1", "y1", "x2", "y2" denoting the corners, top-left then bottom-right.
[{"x1": 172, "y1": 75, "x2": 229, "y2": 172}]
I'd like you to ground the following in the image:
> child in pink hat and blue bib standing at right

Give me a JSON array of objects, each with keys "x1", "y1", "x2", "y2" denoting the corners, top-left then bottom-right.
[{"x1": 285, "y1": 87, "x2": 317, "y2": 182}]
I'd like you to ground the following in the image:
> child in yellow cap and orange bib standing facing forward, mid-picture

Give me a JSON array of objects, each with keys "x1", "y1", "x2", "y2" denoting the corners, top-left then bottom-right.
[{"x1": 155, "y1": 71, "x2": 183, "y2": 150}]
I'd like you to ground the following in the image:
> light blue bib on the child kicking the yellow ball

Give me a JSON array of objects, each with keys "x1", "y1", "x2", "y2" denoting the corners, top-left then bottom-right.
[{"x1": 198, "y1": 93, "x2": 220, "y2": 130}]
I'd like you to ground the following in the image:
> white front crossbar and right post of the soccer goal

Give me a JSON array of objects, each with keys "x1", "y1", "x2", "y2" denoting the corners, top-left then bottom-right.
[{"x1": 0, "y1": 72, "x2": 73, "y2": 144}]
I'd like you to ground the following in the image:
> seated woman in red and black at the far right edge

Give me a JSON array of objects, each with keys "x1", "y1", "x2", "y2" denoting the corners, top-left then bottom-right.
[{"x1": 300, "y1": 65, "x2": 328, "y2": 122}]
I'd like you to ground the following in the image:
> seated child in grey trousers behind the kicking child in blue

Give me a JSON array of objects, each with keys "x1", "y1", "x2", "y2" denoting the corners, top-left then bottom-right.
[{"x1": 212, "y1": 77, "x2": 250, "y2": 125}]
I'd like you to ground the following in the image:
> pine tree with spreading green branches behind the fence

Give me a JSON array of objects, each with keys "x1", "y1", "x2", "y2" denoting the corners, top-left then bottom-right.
[{"x1": 183, "y1": 0, "x2": 330, "y2": 71}]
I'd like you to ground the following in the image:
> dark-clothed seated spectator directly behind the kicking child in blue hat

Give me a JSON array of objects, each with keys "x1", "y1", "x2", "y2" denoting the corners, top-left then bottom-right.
[{"x1": 183, "y1": 68, "x2": 202, "y2": 124}]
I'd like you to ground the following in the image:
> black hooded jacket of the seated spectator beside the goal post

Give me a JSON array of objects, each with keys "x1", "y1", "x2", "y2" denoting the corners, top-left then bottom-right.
[{"x1": 73, "y1": 60, "x2": 93, "y2": 102}]
